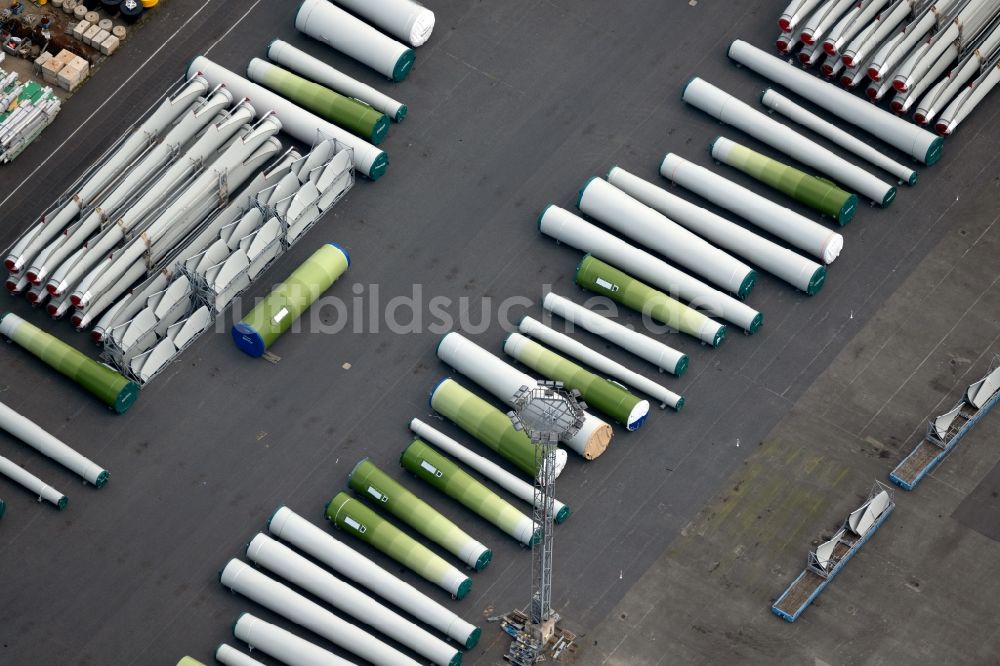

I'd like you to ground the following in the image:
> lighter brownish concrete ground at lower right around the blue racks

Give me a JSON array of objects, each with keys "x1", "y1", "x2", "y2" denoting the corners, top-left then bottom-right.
[{"x1": 580, "y1": 178, "x2": 1000, "y2": 666}]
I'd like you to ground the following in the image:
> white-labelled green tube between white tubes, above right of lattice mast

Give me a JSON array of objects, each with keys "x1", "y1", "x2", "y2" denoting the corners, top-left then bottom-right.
[{"x1": 574, "y1": 254, "x2": 726, "y2": 347}]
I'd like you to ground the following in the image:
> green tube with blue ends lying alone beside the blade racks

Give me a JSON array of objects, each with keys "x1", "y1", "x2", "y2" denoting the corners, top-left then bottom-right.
[{"x1": 232, "y1": 243, "x2": 351, "y2": 356}]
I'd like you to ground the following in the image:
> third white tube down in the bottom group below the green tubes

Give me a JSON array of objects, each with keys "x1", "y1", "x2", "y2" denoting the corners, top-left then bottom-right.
[{"x1": 219, "y1": 559, "x2": 418, "y2": 666}]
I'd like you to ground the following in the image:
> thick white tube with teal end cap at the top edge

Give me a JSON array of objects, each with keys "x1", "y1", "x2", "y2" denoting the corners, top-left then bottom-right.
[{"x1": 295, "y1": 0, "x2": 414, "y2": 81}]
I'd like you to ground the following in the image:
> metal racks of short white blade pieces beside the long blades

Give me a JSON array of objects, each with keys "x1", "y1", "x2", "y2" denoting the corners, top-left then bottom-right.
[{"x1": 95, "y1": 139, "x2": 353, "y2": 383}]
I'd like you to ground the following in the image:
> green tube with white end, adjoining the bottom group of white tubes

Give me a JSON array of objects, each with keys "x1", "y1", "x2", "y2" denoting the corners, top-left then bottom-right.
[{"x1": 326, "y1": 493, "x2": 472, "y2": 599}]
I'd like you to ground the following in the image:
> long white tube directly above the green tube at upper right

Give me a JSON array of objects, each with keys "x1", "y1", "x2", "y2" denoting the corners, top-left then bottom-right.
[{"x1": 681, "y1": 77, "x2": 896, "y2": 208}]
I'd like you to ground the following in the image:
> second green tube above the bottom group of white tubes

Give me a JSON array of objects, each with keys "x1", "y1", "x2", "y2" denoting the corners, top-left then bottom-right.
[{"x1": 347, "y1": 458, "x2": 493, "y2": 571}]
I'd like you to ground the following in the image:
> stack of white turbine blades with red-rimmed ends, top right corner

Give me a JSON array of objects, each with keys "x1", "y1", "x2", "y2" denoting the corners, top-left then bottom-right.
[{"x1": 778, "y1": 0, "x2": 1000, "y2": 134}]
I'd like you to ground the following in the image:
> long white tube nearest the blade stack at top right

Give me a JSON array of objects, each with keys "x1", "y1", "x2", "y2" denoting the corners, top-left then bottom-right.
[{"x1": 729, "y1": 39, "x2": 944, "y2": 166}]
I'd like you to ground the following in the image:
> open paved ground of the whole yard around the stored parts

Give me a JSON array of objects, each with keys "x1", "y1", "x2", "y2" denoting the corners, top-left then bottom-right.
[{"x1": 0, "y1": 0, "x2": 1000, "y2": 665}]
